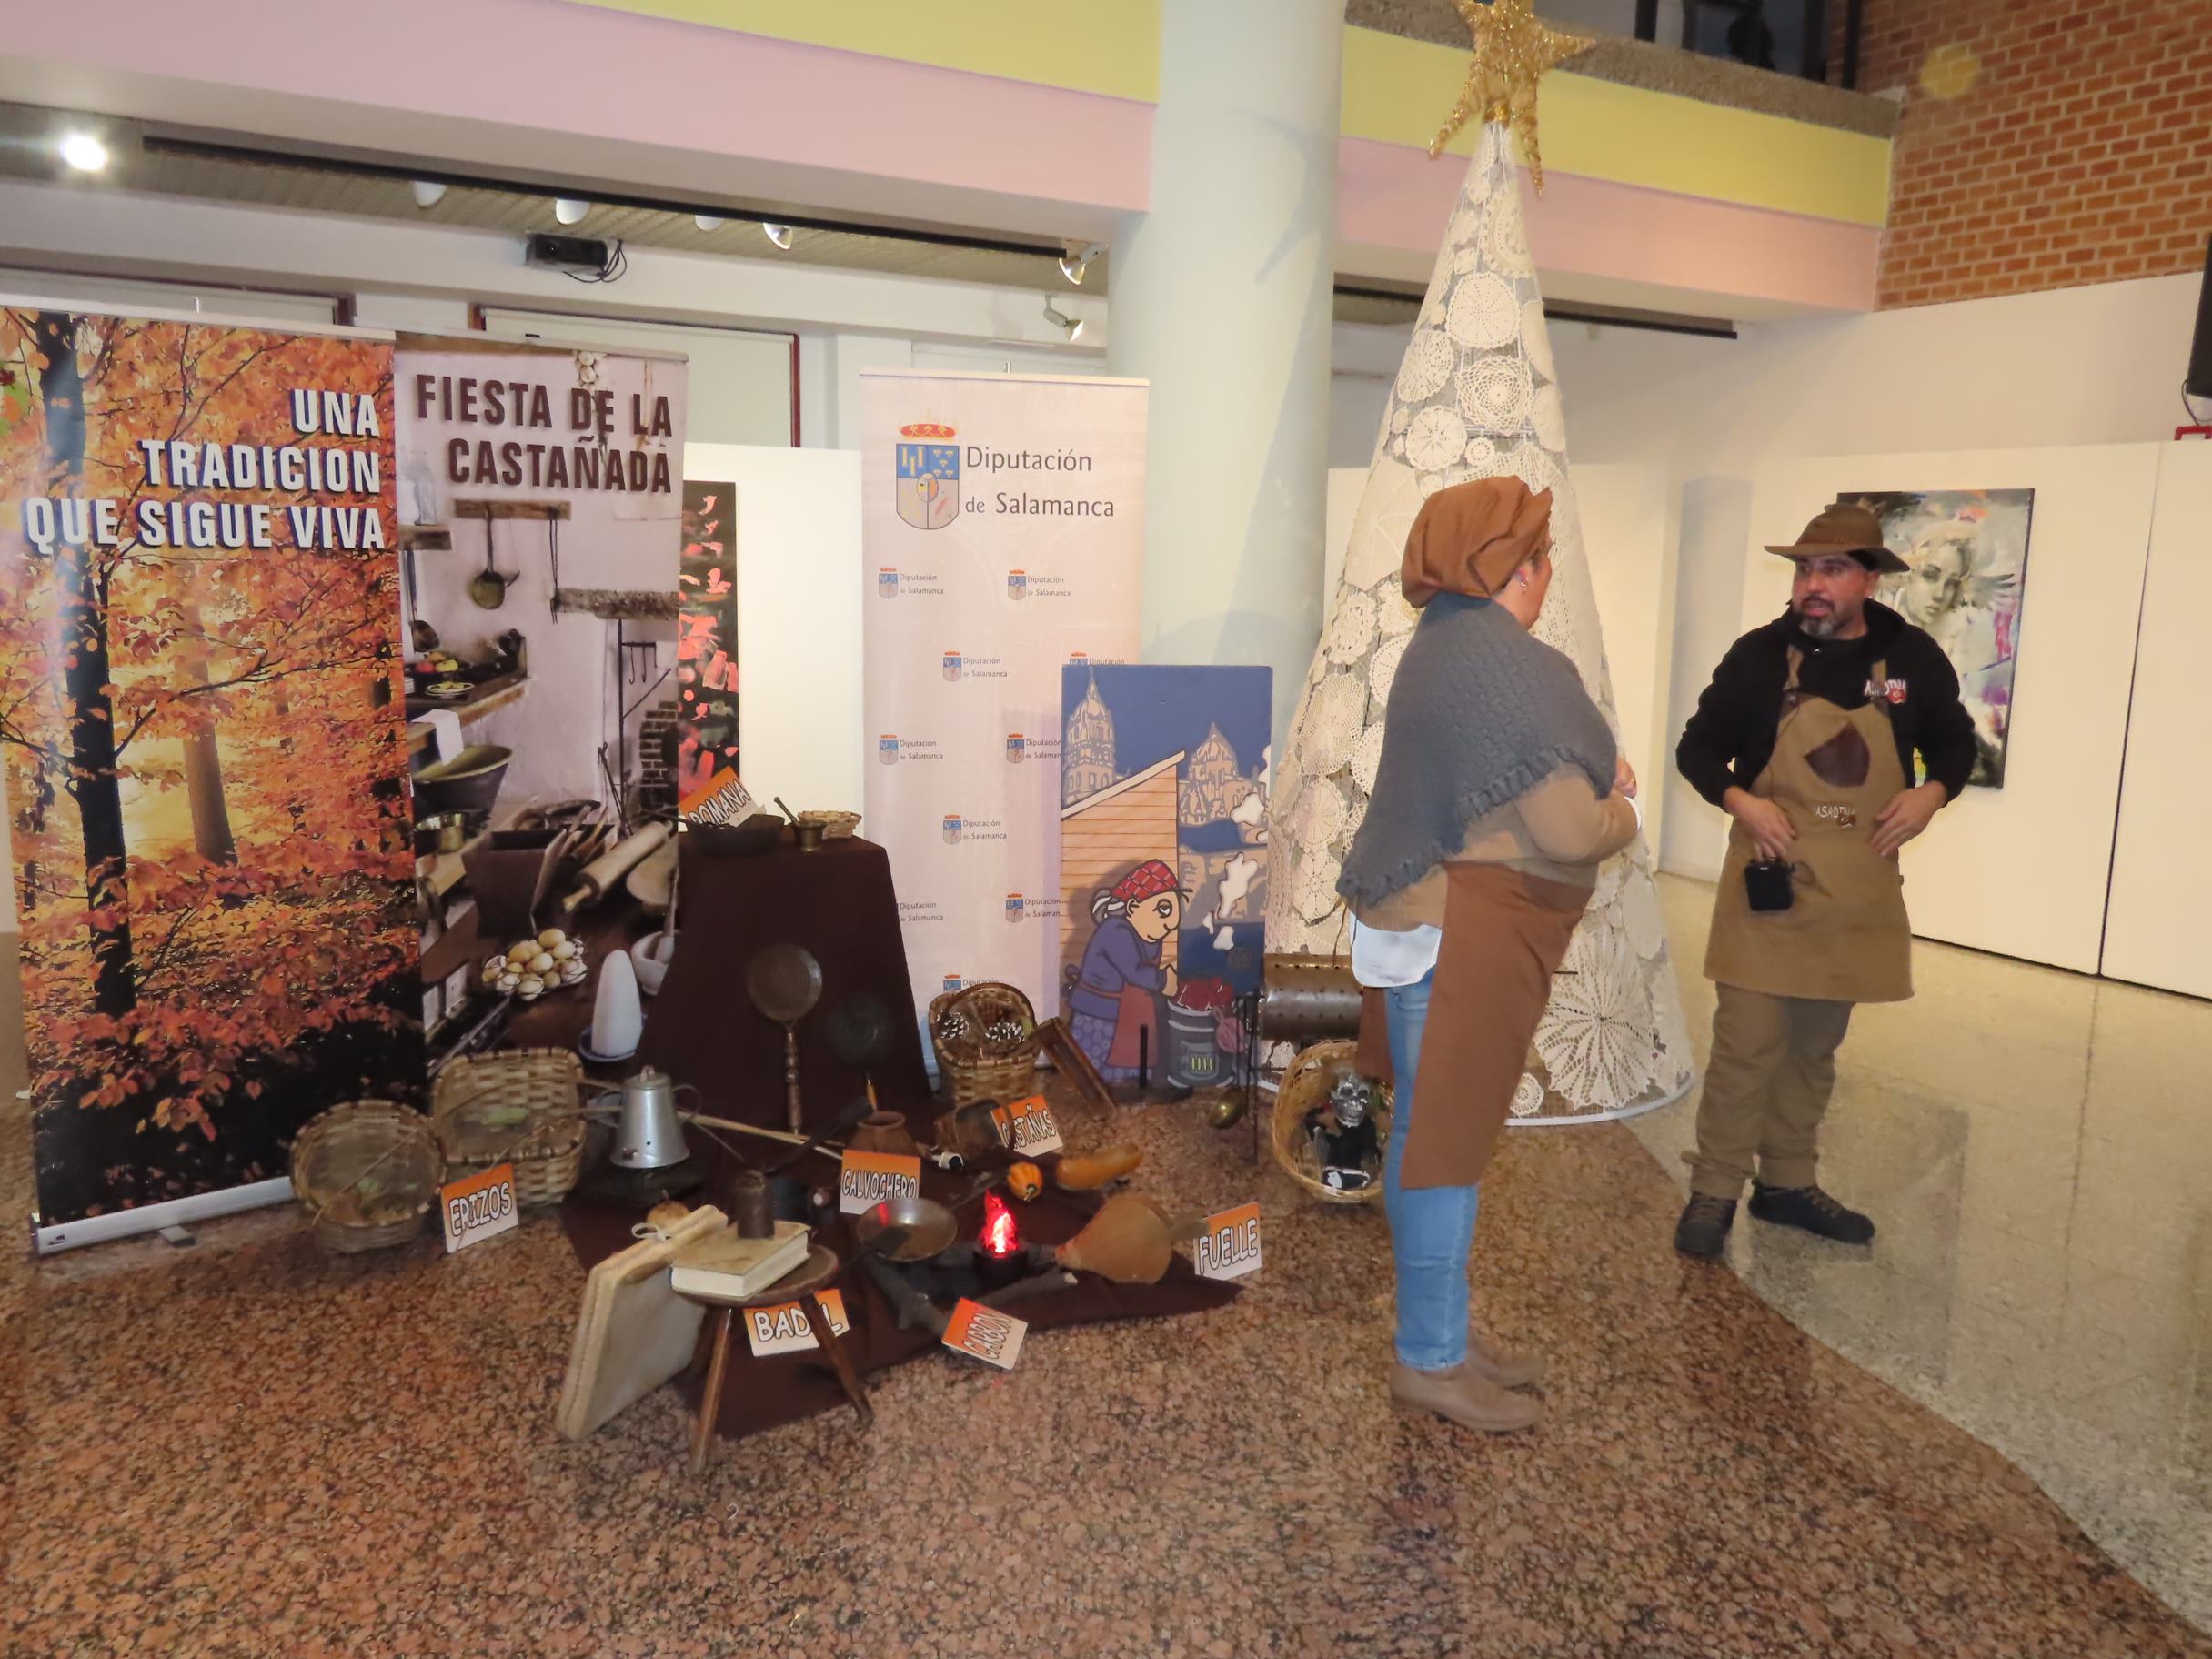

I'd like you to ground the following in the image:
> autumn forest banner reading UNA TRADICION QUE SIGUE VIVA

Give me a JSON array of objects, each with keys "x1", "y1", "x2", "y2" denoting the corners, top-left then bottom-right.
[{"x1": 0, "y1": 307, "x2": 423, "y2": 1225}]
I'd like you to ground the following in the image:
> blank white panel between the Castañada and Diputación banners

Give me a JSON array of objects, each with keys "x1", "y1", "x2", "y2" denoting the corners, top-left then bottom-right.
[{"x1": 683, "y1": 445, "x2": 867, "y2": 818}]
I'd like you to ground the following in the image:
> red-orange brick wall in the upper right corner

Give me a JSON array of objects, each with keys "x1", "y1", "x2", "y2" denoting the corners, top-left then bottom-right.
[{"x1": 1829, "y1": 0, "x2": 2212, "y2": 307}]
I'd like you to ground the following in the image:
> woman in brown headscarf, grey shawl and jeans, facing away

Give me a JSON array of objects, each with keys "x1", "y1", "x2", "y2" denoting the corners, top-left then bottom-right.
[{"x1": 1338, "y1": 478, "x2": 1642, "y2": 1433}]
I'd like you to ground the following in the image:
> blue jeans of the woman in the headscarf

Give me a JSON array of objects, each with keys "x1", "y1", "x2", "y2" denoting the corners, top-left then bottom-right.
[{"x1": 1382, "y1": 969, "x2": 1478, "y2": 1372}]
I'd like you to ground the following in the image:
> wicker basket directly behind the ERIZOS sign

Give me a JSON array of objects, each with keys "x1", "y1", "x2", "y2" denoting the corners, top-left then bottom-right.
[{"x1": 431, "y1": 1049, "x2": 584, "y2": 1205}]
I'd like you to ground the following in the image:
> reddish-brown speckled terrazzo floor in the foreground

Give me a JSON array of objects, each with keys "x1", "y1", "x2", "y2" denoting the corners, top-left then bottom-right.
[{"x1": 0, "y1": 924, "x2": 2212, "y2": 1659}]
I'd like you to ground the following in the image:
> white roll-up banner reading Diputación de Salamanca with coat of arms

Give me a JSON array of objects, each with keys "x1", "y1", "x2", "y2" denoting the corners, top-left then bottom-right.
[{"x1": 860, "y1": 372, "x2": 1151, "y2": 1046}]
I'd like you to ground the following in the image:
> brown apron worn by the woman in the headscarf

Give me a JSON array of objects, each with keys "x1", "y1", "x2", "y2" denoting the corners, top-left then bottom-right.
[{"x1": 1361, "y1": 862, "x2": 1591, "y2": 1188}]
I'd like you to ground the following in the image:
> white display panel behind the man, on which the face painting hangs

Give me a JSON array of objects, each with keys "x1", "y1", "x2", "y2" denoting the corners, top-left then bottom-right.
[{"x1": 1714, "y1": 445, "x2": 2159, "y2": 973}]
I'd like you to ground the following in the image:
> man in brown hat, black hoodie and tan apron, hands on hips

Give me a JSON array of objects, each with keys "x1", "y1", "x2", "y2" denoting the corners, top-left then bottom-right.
[{"x1": 1674, "y1": 502, "x2": 1973, "y2": 1259}]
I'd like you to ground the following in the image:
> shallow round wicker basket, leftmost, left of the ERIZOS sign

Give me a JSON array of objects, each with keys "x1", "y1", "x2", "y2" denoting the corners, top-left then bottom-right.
[{"x1": 292, "y1": 1100, "x2": 445, "y2": 1256}]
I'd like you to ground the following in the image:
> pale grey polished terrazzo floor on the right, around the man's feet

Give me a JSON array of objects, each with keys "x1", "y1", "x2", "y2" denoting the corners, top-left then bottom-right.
[{"x1": 1633, "y1": 880, "x2": 2212, "y2": 1628}]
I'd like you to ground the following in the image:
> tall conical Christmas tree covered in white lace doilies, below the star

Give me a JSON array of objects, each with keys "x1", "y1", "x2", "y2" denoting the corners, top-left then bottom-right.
[{"x1": 1268, "y1": 124, "x2": 1694, "y2": 1121}]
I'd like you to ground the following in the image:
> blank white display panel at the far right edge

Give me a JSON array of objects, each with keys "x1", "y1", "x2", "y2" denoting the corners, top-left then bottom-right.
[{"x1": 2104, "y1": 442, "x2": 2212, "y2": 998}]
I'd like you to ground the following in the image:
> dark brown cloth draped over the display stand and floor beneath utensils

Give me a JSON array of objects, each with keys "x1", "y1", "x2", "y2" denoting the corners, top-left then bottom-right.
[{"x1": 562, "y1": 836, "x2": 1236, "y2": 1438}]
